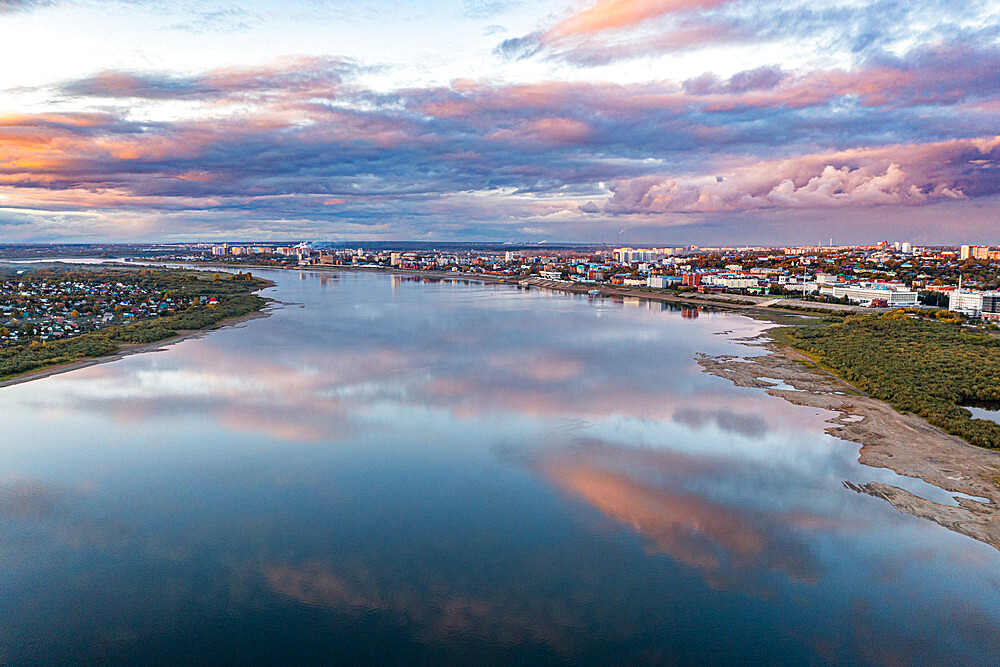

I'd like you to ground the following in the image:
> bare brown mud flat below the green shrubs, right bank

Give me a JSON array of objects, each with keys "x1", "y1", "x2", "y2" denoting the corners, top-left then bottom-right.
[{"x1": 697, "y1": 341, "x2": 1000, "y2": 550}]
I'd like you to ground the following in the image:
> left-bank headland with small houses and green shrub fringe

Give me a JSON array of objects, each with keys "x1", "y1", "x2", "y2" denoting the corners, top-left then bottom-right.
[{"x1": 0, "y1": 264, "x2": 271, "y2": 386}]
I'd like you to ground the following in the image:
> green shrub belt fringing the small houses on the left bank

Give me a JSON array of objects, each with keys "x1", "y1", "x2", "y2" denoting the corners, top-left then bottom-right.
[{"x1": 0, "y1": 269, "x2": 266, "y2": 380}]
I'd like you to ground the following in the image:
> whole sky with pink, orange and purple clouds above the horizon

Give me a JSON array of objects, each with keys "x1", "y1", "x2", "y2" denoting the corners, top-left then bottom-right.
[{"x1": 0, "y1": 0, "x2": 1000, "y2": 245}]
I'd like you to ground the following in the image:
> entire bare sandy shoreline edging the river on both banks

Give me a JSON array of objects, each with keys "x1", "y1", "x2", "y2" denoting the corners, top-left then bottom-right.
[{"x1": 9, "y1": 264, "x2": 1000, "y2": 550}]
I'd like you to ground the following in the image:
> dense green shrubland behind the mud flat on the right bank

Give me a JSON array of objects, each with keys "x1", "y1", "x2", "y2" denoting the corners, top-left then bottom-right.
[{"x1": 783, "y1": 313, "x2": 1000, "y2": 448}]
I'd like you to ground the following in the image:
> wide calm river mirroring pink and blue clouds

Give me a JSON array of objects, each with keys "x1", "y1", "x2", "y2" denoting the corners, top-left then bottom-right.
[{"x1": 0, "y1": 271, "x2": 1000, "y2": 664}]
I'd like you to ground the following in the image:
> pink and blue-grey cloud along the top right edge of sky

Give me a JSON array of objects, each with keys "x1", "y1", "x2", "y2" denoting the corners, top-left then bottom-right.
[{"x1": 494, "y1": 0, "x2": 1000, "y2": 67}]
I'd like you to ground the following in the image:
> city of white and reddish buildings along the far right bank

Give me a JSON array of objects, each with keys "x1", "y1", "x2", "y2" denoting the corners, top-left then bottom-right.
[{"x1": 189, "y1": 241, "x2": 1000, "y2": 323}]
